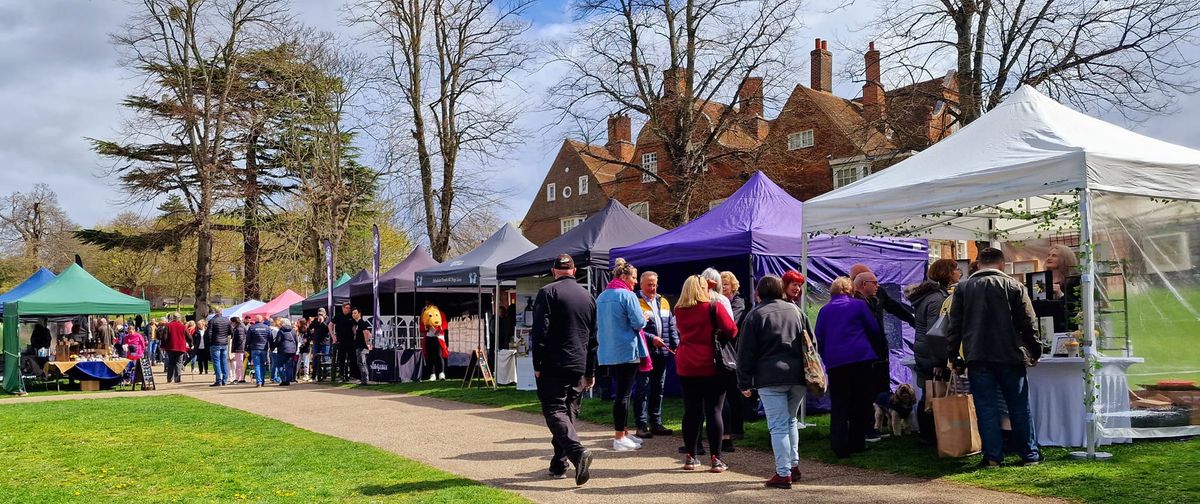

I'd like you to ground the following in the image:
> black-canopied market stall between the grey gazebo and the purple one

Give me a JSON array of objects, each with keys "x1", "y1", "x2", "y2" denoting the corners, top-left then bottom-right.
[{"x1": 496, "y1": 199, "x2": 666, "y2": 385}]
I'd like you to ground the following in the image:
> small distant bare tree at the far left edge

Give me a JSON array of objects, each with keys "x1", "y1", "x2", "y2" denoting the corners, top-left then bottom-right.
[{"x1": 0, "y1": 184, "x2": 76, "y2": 268}]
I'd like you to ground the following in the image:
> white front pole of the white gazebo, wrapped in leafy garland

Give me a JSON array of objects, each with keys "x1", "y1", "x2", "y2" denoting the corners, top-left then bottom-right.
[{"x1": 1070, "y1": 188, "x2": 1112, "y2": 460}]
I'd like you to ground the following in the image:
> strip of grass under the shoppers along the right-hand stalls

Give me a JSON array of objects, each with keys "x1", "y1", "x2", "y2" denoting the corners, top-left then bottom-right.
[{"x1": 349, "y1": 382, "x2": 1200, "y2": 503}]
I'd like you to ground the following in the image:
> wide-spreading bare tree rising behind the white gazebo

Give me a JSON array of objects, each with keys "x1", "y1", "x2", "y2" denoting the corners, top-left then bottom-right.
[{"x1": 869, "y1": 0, "x2": 1200, "y2": 125}]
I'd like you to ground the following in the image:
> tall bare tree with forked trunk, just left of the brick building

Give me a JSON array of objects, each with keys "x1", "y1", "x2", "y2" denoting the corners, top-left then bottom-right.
[{"x1": 352, "y1": 0, "x2": 533, "y2": 260}]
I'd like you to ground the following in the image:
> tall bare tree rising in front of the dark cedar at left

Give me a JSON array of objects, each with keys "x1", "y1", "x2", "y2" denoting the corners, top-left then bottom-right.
[{"x1": 84, "y1": 0, "x2": 287, "y2": 317}]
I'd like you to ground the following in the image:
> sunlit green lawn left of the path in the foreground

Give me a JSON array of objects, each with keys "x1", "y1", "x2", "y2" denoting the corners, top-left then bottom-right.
[{"x1": 0, "y1": 396, "x2": 526, "y2": 503}]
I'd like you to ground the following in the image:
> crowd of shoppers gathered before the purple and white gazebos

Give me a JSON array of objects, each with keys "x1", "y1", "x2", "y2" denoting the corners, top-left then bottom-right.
[{"x1": 530, "y1": 248, "x2": 1042, "y2": 488}]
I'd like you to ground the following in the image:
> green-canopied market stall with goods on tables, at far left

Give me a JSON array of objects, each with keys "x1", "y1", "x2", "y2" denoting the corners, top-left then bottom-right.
[{"x1": 2, "y1": 264, "x2": 150, "y2": 392}]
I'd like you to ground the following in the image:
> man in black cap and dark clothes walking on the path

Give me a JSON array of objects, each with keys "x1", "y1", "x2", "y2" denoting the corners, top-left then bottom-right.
[{"x1": 529, "y1": 254, "x2": 596, "y2": 485}]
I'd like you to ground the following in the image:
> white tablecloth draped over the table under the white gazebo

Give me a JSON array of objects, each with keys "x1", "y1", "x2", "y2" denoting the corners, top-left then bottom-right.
[{"x1": 1028, "y1": 356, "x2": 1144, "y2": 446}]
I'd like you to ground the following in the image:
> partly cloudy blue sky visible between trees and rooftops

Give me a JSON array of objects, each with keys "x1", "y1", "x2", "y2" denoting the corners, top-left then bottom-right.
[{"x1": 0, "y1": 0, "x2": 1200, "y2": 232}]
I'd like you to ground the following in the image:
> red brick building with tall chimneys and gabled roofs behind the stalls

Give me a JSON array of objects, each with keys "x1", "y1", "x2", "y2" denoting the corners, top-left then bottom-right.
[{"x1": 521, "y1": 40, "x2": 955, "y2": 245}]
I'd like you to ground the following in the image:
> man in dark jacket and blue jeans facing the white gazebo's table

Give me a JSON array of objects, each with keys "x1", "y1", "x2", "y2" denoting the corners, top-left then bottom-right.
[{"x1": 947, "y1": 247, "x2": 1042, "y2": 468}]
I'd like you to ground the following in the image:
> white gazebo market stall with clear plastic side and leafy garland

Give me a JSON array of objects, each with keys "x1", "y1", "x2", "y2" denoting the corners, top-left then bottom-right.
[{"x1": 804, "y1": 86, "x2": 1200, "y2": 456}]
